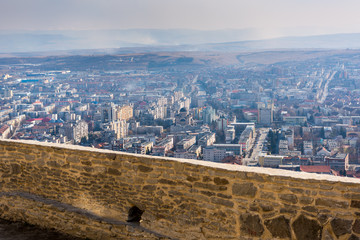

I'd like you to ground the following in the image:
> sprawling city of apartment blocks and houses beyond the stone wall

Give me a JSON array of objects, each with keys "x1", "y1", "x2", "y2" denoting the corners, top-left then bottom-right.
[{"x1": 0, "y1": 50, "x2": 360, "y2": 177}]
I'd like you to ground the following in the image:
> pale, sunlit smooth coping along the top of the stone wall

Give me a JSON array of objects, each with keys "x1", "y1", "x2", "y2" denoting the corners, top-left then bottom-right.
[{"x1": 0, "y1": 139, "x2": 360, "y2": 184}]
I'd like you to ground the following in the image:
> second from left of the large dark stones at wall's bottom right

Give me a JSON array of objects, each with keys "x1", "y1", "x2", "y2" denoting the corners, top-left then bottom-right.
[{"x1": 264, "y1": 216, "x2": 291, "y2": 238}]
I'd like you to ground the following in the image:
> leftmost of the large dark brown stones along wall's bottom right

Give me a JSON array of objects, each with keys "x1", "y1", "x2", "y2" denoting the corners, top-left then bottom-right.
[{"x1": 240, "y1": 213, "x2": 264, "y2": 237}]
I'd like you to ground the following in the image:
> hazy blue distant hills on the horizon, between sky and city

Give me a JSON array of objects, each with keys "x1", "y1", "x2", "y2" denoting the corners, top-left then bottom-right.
[{"x1": 0, "y1": 29, "x2": 360, "y2": 55}]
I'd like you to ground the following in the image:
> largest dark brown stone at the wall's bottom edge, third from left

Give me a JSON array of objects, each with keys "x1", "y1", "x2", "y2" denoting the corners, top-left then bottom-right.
[{"x1": 292, "y1": 215, "x2": 322, "y2": 240}]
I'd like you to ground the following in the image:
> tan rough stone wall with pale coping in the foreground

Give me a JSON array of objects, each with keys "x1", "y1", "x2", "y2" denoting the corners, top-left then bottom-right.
[{"x1": 0, "y1": 140, "x2": 360, "y2": 239}]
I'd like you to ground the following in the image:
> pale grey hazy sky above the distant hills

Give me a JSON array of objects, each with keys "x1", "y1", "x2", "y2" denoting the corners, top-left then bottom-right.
[{"x1": 0, "y1": 0, "x2": 360, "y2": 36}]
